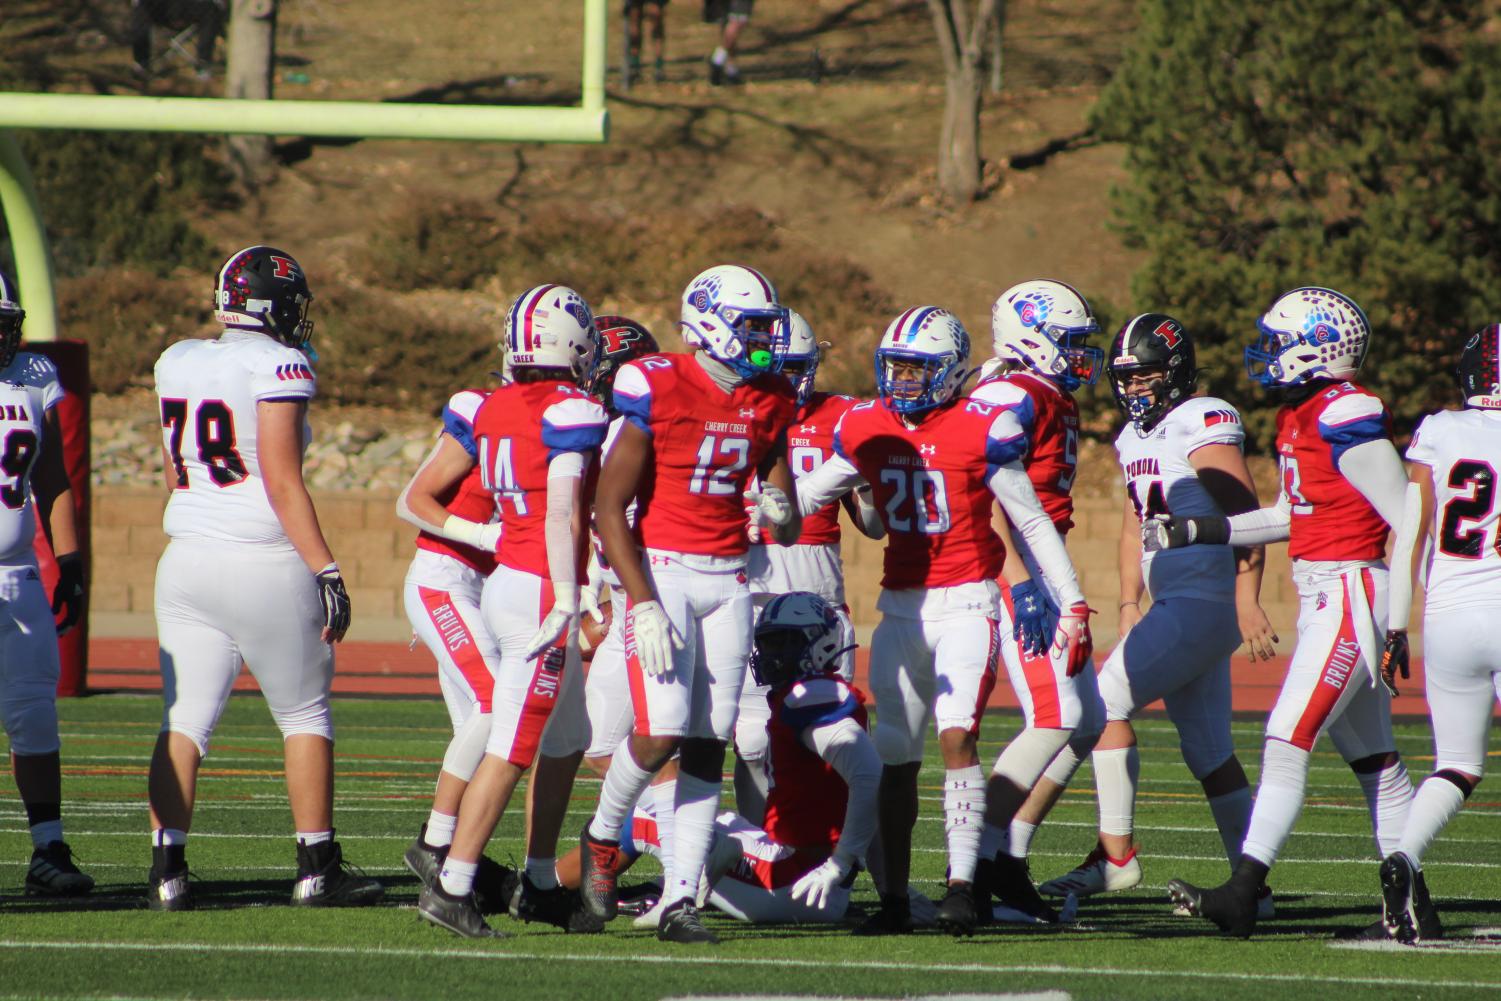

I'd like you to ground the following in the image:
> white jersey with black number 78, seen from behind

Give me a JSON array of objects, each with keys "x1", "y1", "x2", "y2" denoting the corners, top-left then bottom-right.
[{"x1": 156, "y1": 330, "x2": 317, "y2": 549}]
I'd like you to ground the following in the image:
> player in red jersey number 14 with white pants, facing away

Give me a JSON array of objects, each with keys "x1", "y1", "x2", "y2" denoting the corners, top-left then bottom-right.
[{"x1": 417, "y1": 285, "x2": 608, "y2": 938}]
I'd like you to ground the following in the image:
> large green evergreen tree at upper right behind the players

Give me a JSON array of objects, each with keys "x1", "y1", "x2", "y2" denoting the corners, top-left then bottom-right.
[{"x1": 1093, "y1": 0, "x2": 1501, "y2": 440}]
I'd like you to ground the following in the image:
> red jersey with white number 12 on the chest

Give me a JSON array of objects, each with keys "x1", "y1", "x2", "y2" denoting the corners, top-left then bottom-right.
[{"x1": 609, "y1": 354, "x2": 797, "y2": 557}]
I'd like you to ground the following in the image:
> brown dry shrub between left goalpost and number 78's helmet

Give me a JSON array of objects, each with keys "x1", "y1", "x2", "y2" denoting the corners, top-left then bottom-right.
[{"x1": 57, "y1": 270, "x2": 215, "y2": 393}]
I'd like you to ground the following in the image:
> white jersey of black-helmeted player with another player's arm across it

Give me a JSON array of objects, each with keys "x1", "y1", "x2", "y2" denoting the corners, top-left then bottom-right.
[{"x1": 1115, "y1": 396, "x2": 1246, "y2": 602}]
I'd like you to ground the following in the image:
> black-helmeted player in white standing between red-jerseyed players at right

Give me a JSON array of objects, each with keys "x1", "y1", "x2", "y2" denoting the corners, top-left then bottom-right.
[{"x1": 1022, "y1": 312, "x2": 1276, "y2": 908}]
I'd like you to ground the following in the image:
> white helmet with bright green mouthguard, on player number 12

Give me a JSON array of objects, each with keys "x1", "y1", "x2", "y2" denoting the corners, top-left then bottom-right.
[{"x1": 680, "y1": 264, "x2": 787, "y2": 378}]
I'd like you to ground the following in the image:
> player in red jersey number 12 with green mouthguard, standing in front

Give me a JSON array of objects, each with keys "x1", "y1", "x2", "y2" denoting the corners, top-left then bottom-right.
[{"x1": 579, "y1": 264, "x2": 802, "y2": 942}]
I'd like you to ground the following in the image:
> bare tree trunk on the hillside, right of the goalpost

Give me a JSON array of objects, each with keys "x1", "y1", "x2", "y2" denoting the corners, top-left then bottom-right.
[{"x1": 928, "y1": 0, "x2": 1004, "y2": 201}]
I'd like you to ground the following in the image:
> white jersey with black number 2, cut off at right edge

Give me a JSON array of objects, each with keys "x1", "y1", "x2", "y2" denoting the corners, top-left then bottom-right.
[{"x1": 1408, "y1": 410, "x2": 1501, "y2": 612}]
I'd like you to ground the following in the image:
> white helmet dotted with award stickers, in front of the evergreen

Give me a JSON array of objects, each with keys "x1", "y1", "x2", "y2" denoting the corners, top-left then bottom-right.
[{"x1": 1246, "y1": 285, "x2": 1370, "y2": 389}]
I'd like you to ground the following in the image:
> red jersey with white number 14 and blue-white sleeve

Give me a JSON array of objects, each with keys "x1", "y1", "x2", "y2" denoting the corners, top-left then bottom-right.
[{"x1": 474, "y1": 381, "x2": 609, "y2": 578}]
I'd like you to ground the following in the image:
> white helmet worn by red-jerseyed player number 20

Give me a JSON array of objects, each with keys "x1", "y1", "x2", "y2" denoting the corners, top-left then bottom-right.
[{"x1": 875, "y1": 306, "x2": 973, "y2": 414}]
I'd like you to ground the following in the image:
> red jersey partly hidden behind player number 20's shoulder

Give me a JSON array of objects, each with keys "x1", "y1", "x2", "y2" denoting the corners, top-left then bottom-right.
[{"x1": 970, "y1": 372, "x2": 1079, "y2": 536}]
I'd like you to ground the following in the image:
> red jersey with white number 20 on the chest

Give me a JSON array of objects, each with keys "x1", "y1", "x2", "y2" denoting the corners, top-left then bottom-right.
[{"x1": 835, "y1": 399, "x2": 1027, "y2": 591}]
